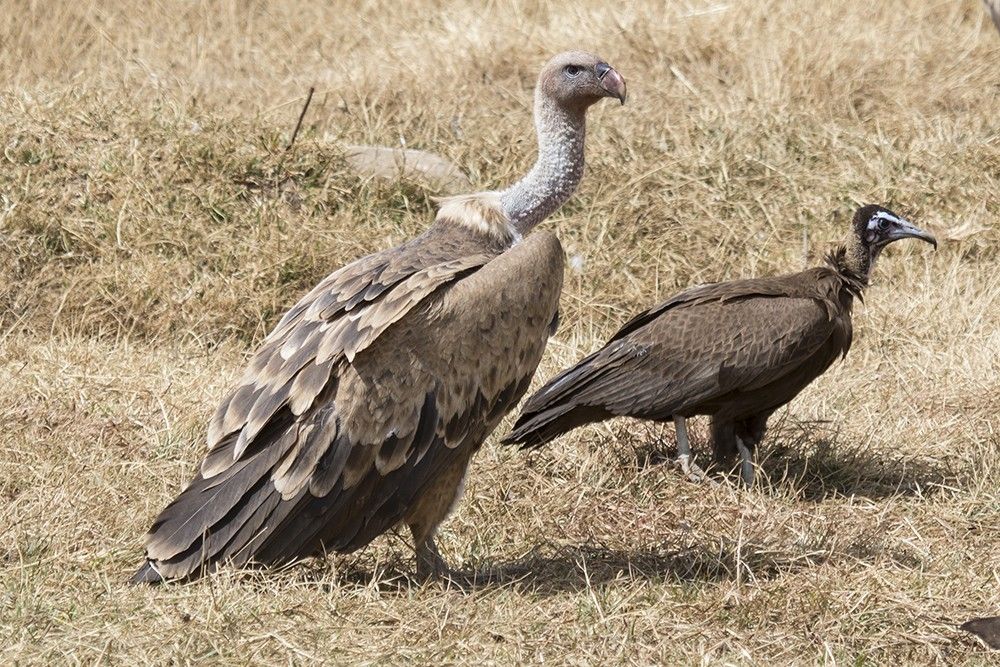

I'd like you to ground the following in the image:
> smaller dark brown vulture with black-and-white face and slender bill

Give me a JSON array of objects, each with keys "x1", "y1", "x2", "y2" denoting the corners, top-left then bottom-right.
[{"x1": 504, "y1": 205, "x2": 937, "y2": 485}]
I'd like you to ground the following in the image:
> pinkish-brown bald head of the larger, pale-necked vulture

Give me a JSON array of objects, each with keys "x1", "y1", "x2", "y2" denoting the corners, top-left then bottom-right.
[{"x1": 536, "y1": 51, "x2": 625, "y2": 111}]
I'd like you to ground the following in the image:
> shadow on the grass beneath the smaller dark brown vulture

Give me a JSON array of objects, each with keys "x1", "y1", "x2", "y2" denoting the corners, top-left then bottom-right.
[{"x1": 635, "y1": 418, "x2": 962, "y2": 501}]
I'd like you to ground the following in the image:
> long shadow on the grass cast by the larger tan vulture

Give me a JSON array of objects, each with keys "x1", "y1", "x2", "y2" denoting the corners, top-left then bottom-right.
[{"x1": 227, "y1": 500, "x2": 922, "y2": 596}]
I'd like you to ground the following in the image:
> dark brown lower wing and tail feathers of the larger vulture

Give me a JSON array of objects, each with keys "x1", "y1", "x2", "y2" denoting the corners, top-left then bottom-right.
[{"x1": 132, "y1": 394, "x2": 452, "y2": 584}]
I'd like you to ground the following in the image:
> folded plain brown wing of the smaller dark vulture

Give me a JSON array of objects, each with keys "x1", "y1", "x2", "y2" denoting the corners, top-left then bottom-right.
[{"x1": 505, "y1": 270, "x2": 843, "y2": 446}]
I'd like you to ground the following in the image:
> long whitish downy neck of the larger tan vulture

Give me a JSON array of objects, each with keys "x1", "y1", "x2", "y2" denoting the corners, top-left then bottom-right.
[{"x1": 500, "y1": 95, "x2": 586, "y2": 236}]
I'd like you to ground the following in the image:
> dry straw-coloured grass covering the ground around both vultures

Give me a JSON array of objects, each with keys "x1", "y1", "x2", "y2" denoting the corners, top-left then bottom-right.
[{"x1": 0, "y1": 0, "x2": 1000, "y2": 664}]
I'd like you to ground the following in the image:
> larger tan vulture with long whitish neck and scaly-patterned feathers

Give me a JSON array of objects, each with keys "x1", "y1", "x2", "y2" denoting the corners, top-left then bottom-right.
[{"x1": 132, "y1": 51, "x2": 625, "y2": 584}]
